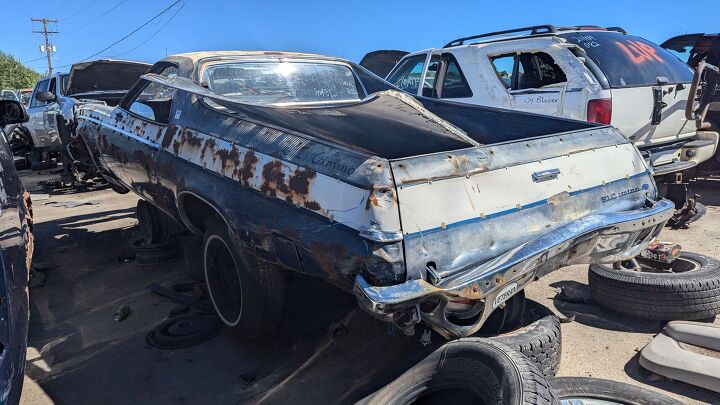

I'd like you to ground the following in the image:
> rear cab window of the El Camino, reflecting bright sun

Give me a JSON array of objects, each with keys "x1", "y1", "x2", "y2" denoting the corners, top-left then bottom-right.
[{"x1": 202, "y1": 61, "x2": 360, "y2": 105}]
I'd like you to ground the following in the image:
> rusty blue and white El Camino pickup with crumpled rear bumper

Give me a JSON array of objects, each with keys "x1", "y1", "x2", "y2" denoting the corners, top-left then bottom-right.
[{"x1": 76, "y1": 51, "x2": 674, "y2": 338}]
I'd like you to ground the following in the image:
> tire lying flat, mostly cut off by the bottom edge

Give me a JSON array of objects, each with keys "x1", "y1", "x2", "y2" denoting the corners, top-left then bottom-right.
[{"x1": 550, "y1": 377, "x2": 682, "y2": 405}]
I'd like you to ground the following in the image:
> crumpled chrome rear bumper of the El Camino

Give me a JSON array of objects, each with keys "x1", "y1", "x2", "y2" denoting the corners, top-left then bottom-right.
[{"x1": 355, "y1": 199, "x2": 675, "y2": 338}]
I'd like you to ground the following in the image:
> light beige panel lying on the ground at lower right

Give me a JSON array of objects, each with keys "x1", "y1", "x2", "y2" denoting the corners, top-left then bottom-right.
[{"x1": 640, "y1": 321, "x2": 720, "y2": 392}]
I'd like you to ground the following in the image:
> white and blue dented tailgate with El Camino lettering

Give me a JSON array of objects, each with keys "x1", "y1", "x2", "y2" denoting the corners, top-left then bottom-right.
[{"x1": 391, "y1": 127, "x2": 655, "y2": 277}]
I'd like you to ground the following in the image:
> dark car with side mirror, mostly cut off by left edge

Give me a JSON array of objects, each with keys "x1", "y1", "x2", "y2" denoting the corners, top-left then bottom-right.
[{"x1": 0, "y1": 100, "x2": 33, "y2": 404}]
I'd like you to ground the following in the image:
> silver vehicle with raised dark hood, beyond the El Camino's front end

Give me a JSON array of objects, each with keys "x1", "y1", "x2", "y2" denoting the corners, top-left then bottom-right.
[{"x1": 15, "y1": 60, "x2": 150, "y2": 172}]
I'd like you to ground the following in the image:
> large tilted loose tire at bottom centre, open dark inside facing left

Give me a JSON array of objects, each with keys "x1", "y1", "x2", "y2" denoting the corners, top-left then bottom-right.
[{"x1": 359, "y1": 338, "x2": 558, "y2": 405}]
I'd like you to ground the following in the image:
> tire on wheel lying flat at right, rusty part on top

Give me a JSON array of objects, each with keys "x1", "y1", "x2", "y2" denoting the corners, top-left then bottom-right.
[{"x1": 589, "y1": 252, "x2": 720, "y2": 321}]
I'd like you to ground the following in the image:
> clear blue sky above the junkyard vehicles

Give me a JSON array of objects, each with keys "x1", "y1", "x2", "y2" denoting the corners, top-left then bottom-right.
[{"x1": 0, "y1": 0, "x2": 720, "y2": 72}]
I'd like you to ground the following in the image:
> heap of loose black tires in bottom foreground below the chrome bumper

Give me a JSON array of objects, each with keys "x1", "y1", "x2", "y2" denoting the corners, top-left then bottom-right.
[{"x1": 358, "y1": 296, "x2": 681, "y2": 405}]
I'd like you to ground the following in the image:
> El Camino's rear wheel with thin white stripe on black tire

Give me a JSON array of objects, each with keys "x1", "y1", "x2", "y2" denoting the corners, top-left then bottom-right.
[{"x1": 202, "y1": 220, "x2": 285, "y2": 339}]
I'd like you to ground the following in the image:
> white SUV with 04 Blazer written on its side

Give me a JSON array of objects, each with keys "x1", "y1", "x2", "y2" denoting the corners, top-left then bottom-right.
[{"x1": 380, "y1": 25, "x2": 718, "y2": 192}]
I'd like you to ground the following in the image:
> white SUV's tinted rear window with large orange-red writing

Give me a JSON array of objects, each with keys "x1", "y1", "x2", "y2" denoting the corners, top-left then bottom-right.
[{"x1": 560, "y1": 31, "x2": 693, "y2": 88}]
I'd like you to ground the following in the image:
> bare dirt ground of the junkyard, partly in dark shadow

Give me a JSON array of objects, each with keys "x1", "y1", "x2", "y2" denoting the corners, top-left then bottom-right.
[{"x1": 14, "y1": 169, "x2": 720, "y2": 404}]
